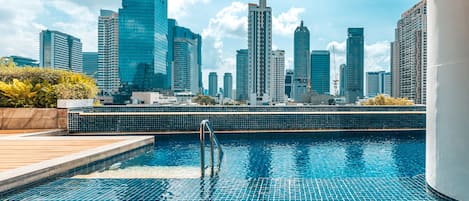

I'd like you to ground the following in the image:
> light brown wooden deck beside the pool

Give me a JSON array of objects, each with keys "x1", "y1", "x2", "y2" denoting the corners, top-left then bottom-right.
[{"x1": 0, "y1": 137, "x2": 123, "y2": 172}]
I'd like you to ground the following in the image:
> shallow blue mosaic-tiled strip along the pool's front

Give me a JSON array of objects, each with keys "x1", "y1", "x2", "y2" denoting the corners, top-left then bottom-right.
[{"x1": 0, "y1": 175, "x2": 437, "y2": 201}]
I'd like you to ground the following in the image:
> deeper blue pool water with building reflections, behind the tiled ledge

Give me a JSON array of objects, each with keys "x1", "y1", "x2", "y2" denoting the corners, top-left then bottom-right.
[{"x1": 101, "y1": 132, "x2": 425, "y2": 179}]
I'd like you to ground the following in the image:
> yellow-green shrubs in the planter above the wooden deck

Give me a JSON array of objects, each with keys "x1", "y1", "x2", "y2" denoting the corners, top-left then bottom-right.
[{"x1": 0, "y1": 59, "x2": 98, "y2": 108}]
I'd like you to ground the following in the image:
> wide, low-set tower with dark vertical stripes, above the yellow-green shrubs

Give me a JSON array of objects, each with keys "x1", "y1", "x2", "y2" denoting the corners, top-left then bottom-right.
[{"x1": 39, "y1": 30, "x2": 83, "y2": 73}]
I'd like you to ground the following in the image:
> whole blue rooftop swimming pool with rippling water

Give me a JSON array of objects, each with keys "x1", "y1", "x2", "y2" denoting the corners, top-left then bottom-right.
[{"x1": 3, "y1": 131, "x2": 436, "y2": 200}]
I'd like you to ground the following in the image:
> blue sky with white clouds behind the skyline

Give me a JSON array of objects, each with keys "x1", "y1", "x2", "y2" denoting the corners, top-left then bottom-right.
[{"x1": 0, "y1": 0, "x2": 419, "y2": 89}]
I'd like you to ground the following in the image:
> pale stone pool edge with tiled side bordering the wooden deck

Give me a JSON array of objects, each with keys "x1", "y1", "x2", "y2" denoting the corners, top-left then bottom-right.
[{"x1": 0, "y1": 137, "x2": 154, "y2": 198}]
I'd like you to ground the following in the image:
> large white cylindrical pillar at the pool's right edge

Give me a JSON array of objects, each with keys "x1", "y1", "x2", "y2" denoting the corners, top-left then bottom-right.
[{"x1": 426, "y1": 0, "x2": 469, "y2": 200}]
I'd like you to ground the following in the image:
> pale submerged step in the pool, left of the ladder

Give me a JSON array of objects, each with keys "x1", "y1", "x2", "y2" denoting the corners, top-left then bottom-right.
[{"x1": 73, "y1": 166, "x2": 200, "y2": 179}]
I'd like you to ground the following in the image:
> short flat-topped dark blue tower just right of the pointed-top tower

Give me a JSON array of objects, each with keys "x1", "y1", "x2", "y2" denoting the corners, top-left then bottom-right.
[{"x1": 311, "y1": 50, "x2": 331, "y2": 94}]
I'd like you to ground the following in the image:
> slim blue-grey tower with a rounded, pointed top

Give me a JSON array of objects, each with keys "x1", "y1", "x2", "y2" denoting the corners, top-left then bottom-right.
[{"x1": 293, "y1": 21, "x2": 311, "y2": 102}]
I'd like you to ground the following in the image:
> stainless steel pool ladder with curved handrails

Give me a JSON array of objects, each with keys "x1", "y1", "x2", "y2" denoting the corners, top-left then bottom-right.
[{"x1": 199, "y1": 120, "x2": 223, "y2": 177}]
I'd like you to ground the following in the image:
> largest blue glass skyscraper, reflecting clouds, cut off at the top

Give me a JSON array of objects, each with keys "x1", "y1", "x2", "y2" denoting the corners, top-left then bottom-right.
[{"x1": 119, "y1": 0, "x2": 170, "y2": 91}]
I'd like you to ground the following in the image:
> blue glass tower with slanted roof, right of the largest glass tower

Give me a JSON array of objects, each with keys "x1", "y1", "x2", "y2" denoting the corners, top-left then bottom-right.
[{"x1": 169, "y1": 23, "x2": 202, "y2": 95}]
